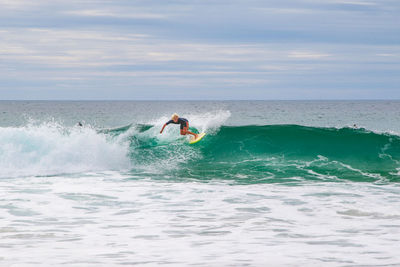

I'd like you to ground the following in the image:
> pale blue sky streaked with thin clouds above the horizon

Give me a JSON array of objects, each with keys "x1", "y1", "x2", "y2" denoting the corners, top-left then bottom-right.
[{"x1": 0, "y1": 0, "x2": 400, "y2": 100}]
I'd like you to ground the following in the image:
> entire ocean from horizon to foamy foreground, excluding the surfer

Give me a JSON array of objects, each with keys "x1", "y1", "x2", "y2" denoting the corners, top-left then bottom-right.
[{"x1": 0, "y1": 101, "x2": 400, "y2": 266}]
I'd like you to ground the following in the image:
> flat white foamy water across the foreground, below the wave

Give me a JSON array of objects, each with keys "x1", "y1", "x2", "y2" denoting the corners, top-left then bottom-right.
[{"x1": 0, "y1": 176, "x2": 400, "y2": 267}]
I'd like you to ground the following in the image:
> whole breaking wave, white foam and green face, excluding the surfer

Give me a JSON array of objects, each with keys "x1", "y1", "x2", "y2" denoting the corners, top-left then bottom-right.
[{"x1": 0, "y1": 120, "x2": 400, "y2": 183}]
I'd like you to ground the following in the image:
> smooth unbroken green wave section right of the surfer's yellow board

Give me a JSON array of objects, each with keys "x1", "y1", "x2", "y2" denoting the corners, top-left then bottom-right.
[{"x1": 193, "y1": 125, "x2": 400, "y2": 184}]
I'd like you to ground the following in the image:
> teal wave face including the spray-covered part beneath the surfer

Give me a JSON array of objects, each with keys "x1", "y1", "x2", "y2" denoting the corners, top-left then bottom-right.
[{"x1": 124, "y1": 125, "x2": 400, "y2": 183}]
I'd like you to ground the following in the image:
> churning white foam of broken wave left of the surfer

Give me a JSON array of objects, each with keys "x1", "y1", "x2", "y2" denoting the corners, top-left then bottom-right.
[{"x1": 0, "y1": 122, "x2": 129, "y2": 177}]
